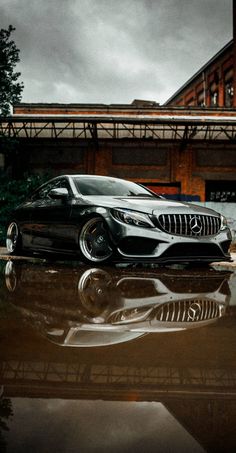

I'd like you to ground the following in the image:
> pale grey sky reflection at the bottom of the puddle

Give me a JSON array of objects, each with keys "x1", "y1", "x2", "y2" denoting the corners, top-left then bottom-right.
[{"x1": 5, "y1": 398, "x2": 204, "y2": 453}]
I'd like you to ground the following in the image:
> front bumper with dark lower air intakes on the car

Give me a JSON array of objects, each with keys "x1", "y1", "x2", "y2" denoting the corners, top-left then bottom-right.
[{"x1": 108, "y1": 219, "x2": 232, "y2": 263}]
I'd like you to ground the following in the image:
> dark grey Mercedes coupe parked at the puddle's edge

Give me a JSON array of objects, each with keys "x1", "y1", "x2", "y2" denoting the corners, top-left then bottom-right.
[{"x1": 6, "y1": 175, "x2": 231, "y2": 263}]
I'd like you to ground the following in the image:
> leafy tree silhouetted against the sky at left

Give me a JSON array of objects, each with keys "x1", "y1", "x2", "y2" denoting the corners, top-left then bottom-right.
[{"x1": 0, "y1": 25, "x2": 24, "y2": 116}]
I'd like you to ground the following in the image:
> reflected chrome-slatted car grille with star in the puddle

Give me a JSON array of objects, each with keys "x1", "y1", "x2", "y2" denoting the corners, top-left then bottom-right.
[{"x1": 154, "y1": 299, "x2": 220, "y2": 322}]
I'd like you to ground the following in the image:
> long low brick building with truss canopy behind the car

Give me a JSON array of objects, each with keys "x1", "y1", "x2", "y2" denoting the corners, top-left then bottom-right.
[{"x1": 2, "y1": 102, "x2": 236, "y2": 201}]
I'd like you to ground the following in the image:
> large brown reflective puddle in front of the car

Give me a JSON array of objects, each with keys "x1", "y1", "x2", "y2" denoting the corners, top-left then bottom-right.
[{"x1": 0, "y1": 254, "x2": 236, "y2": 453}]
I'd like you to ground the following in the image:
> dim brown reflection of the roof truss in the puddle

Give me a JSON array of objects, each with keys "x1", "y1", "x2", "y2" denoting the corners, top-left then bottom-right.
[{"x1": 0, "y1": 360, "x2": 236, "y2": 401}]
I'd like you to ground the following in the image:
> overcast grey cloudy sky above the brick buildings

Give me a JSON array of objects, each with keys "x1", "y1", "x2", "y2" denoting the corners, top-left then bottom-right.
[{"x1": 0, "y1": 0, "x2": 232, "y2": 104}]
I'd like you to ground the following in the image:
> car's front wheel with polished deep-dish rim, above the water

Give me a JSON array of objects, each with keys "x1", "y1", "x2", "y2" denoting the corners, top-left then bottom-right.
[{"x1": 79, "y1": 217, "x2": 113, "y2": 263}]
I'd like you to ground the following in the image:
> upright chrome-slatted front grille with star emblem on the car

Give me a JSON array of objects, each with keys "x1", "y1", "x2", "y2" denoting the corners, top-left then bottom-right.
[{"x1": 158, "y1": 214, "x2": 221, "y2": 237}]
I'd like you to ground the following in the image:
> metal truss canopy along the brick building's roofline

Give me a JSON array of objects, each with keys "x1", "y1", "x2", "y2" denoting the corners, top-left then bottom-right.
[{"x1": 0, "y1": 112, "x2": 236, "y2": 142}]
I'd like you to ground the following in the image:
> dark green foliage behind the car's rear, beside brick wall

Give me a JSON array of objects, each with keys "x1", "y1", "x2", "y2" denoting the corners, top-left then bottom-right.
[{"x1": 0, "y1": 174, "x2": 49, "y2": 245}]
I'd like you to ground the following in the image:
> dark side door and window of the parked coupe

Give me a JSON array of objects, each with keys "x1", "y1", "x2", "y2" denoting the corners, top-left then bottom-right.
[{"x1": 26, "y1": 178, "x2": 72, "y2": 251}]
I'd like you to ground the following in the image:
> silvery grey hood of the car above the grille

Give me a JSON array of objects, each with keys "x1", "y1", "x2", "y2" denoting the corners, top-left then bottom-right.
[{"x1": 81, "y1": 196, "x2": 220, "y2": 215}]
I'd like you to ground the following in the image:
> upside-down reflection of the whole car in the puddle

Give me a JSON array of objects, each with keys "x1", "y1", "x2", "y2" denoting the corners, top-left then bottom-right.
[{"x1": 5, "y1": 261, "x2": 230, "y2": 347}]
